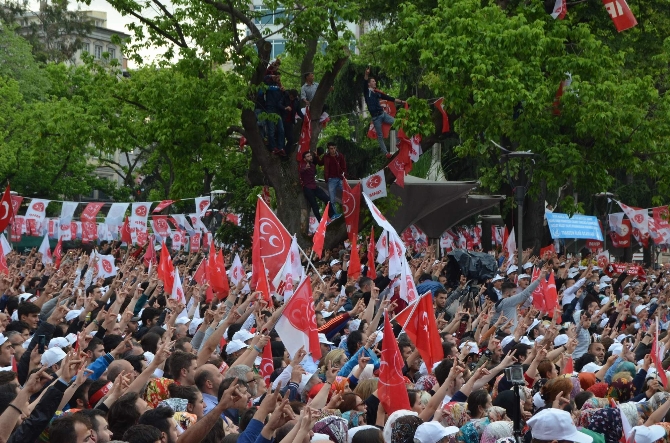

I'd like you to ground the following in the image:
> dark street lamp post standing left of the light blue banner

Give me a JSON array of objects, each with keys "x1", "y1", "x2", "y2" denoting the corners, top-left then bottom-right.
[{"x1": 491, "y1": 140, "x2": 537, "y2": 267}]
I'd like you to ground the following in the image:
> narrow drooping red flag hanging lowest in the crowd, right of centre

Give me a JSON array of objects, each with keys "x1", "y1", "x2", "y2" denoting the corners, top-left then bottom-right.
[{"x1": 380, "y1": 312, "x2": 412, "y2": 415}]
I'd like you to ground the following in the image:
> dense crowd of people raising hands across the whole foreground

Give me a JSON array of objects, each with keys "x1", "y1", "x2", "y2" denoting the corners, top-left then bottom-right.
[{"x1": 0, "y1": 239, "x2": 670, "y2": 443}]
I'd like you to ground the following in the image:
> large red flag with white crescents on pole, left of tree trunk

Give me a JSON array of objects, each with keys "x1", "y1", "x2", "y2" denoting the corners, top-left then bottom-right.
[{"x1": 251, "y1": 198, "x2": 292, "y2": 287}]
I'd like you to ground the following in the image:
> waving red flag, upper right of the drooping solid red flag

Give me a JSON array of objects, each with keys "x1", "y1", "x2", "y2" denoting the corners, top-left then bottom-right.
[{"x1": 396, "y1": 293, "x2": 444, "y2": 374}]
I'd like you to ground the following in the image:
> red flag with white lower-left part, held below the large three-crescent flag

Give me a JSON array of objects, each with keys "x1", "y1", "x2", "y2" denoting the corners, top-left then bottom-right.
[{"x1": 275, "y1": 278, "x2": 322, "y2": 360}]
